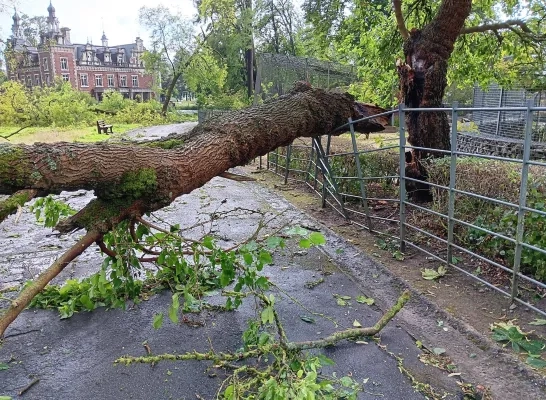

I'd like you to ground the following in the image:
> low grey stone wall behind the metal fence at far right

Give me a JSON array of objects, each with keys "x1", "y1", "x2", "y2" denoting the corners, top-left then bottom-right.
[{"x1": 457, "y1": 132, "x2": 546, "y2": 160}]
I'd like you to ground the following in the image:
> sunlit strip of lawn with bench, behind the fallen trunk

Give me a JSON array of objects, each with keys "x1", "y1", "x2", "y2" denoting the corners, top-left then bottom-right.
[{"x1": 0, "y1": 124, "x2": 141, "y2": 144}]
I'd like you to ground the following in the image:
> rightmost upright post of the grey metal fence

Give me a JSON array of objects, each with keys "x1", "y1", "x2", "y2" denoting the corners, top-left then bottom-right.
[{"x1": 510, "y1": 100, "x2": 533, "y2": 301}]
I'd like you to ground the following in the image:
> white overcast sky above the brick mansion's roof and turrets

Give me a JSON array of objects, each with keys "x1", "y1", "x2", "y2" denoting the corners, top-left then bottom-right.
[{"x1": 0, "y1": 0, "x2": 196, "y2": 46}]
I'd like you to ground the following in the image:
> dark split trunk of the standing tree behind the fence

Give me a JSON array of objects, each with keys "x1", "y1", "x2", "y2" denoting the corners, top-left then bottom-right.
[{"x1": 398, "y1": 0, "x2": 472, "y2": 200}]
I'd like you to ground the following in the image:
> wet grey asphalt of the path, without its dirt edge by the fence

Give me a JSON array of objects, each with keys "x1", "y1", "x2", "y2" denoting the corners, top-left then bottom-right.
[{"x1": 0, "y1": 123, "x2": 423, "y2": 400}]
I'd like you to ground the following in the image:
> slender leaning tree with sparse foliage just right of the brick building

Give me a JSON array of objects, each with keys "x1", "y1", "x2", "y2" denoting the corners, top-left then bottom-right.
[{"x1": 139, "y1": 5, "x2": 196, "y2": 115}]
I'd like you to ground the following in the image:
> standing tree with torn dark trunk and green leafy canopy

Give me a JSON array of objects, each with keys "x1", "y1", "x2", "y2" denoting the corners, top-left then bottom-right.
[{"x1": 304, "y1": 0, "x2": 546, "y2": 180}]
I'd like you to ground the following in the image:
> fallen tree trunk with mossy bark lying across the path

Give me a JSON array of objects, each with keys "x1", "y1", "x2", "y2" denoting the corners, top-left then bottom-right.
[{"x1": 0, "y1": 83, "x2": 388, "y2": 337}]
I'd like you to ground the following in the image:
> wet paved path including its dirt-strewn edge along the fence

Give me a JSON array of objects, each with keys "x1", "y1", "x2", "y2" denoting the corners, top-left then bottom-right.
[{"x1": 5, "y1": 123, "x2": 546, "y2": 400}]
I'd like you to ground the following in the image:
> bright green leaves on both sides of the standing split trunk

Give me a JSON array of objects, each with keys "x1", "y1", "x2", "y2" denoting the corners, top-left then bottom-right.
[{"x1": 303, "y1": 0, "x2": 546, "y2": 105}]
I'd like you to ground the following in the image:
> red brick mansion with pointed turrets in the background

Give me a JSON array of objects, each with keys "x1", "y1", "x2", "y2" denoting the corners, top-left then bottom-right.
[{"x1": 6, "y1": 2, "x2": 154, "y2": 100}]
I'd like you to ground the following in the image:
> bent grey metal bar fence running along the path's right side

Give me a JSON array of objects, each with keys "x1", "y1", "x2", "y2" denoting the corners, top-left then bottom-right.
[{"x1": 267, "y1": 101, "x2": 546, "y2": 315}]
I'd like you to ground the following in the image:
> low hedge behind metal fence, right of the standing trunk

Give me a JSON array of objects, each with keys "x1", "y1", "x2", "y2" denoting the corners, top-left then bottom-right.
[{"x1": 428, "y1": 157, "x2": 546, "y2": 281}]
